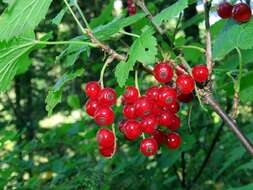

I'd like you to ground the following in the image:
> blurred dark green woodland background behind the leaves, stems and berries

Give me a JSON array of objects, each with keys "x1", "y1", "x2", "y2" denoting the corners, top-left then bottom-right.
[{"x1": 0, "y1": 0, "x2": 253, "y2": 190}]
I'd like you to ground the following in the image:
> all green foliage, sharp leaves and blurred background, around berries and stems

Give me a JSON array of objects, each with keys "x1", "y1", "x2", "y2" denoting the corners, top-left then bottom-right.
[{"x1": 0, "y1": 0, "x2": 253, "y2": 190}]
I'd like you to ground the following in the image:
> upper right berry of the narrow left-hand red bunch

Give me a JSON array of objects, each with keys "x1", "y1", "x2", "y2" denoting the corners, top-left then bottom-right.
[{"x1": 98, "y1": 88, "x2": 117, "y2": 106}]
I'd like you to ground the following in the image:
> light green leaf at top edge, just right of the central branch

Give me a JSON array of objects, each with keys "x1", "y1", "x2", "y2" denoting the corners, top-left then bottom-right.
[{"x1": 153, "y1": 0, "x2": 188, "y2": 25}]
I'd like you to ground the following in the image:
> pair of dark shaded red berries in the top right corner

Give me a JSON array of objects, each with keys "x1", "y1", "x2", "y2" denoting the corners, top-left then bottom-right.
[{"x1": 217, "y1": 2, "x2": 252, "y2": 23}]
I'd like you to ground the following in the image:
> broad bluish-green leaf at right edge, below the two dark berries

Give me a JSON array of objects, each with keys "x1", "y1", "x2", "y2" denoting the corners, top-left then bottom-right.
[{"x1": 213, "y1": 20, "x2": 253, "y2": 60}]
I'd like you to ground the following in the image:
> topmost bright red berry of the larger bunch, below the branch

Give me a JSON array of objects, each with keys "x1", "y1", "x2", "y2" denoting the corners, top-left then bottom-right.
[{"x1": 154, "y1": 63, "x2": 173, "y2": 83}]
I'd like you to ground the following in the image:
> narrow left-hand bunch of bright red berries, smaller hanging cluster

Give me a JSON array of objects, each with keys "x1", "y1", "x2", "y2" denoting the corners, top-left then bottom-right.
[{"x1": 85, "y1": 82, "x2": 117, "y2": 157}]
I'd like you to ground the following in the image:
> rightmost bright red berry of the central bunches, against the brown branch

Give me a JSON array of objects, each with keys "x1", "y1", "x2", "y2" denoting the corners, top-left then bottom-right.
[{"x1": 192, "y1": 65, "x2": 208, "y2": 83}]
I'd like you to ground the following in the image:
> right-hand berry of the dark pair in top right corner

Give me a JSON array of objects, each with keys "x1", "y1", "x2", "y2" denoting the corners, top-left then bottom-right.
[{"x1": 232, "y1": 3, "x2": 252, "y2": 23}]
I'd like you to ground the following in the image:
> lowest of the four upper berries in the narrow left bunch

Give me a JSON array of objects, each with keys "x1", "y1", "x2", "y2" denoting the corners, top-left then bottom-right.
[{"x1": 94, "y1": 107, "x2": 114, "y2": 126}]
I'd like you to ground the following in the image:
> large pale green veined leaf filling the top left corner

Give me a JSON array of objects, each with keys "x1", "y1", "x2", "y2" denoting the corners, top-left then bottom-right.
[{"x1": 0, "y1": 0, "x2": 52, "y2": 40}]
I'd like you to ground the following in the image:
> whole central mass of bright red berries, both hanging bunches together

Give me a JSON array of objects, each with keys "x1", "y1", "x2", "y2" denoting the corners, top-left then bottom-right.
[{"x1": 85, "y1": 62, "x2": 209, "y2": 157}]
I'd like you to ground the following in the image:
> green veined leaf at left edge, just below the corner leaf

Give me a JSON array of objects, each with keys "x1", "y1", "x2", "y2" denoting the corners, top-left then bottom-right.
[{"x1": 0, "y1": 34, "x2": 35, "y2": 91}]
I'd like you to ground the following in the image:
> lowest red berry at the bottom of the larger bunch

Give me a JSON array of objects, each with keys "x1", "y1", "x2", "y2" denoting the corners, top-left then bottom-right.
[{"x1": 140, "y1": 138, "x2": 158, "y2": 156}]
